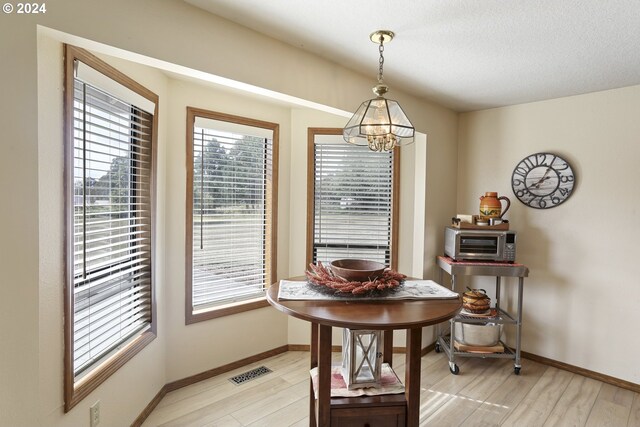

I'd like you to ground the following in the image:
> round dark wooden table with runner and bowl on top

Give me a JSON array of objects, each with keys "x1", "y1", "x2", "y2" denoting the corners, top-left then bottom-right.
[{"x1": 267, "y1": 277, "x2": 462, "y2": 427}]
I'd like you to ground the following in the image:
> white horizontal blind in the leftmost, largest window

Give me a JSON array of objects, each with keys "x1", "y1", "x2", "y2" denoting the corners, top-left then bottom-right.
[{"x1": 70, "y1": 79, "x2": 153, "y2": 378}]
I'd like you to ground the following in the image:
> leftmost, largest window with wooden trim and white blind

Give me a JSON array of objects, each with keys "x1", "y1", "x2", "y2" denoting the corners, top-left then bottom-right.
[{"x1": 65, "y1": 46, "x2": 158, "y2": 411}]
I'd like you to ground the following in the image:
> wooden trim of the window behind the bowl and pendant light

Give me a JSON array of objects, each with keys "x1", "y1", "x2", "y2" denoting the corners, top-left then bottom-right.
[{"x1": 305, "y1": 128, "x2": 400, "y2": 270}]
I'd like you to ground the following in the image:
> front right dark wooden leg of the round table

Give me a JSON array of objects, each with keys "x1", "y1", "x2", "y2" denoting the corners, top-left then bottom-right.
[{"x1": 404, "y1": 328, "x2": 422, "y2": 427}]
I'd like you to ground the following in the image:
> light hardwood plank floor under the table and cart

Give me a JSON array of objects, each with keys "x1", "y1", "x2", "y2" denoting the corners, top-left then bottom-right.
[{"x1": 143, "y1": 351, "x2": 640, "y2": 427}]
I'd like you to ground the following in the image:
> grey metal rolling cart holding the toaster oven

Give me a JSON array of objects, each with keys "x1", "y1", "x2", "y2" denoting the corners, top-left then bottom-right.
[{"x1": 435, "y1": 256, "x2": 529, "y2": 375}]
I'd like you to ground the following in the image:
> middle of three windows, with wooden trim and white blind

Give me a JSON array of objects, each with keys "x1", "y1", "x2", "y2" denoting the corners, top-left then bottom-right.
[{"x1": 186, "y1": 107, "x2": 278, "y2": 323}]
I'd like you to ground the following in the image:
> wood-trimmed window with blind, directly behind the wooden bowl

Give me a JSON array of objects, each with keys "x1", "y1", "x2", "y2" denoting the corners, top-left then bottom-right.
[{"x1": 307, "y1": 128, "x2": 399, "y2": 268}]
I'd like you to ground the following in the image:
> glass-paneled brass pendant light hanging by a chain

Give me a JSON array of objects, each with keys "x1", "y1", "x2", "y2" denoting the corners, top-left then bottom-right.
[{"x1": 342, "y1": 30, "x2": 415, "y2": 152}]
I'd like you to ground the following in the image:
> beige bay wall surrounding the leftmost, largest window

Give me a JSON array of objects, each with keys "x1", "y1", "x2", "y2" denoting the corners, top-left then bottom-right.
[{"x1": 35, "y1": 36, "x2": 168, "y2": 426}]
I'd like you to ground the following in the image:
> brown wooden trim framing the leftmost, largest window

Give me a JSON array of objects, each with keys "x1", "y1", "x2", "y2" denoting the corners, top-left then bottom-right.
[{"x1": 64, "y1": 44, "x2": 158, "y2": 412}]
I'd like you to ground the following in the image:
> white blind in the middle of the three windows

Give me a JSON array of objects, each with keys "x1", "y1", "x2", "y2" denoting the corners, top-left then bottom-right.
[{"x1": 191, "y1": 117, "x2": 273, "y2": 311}]
